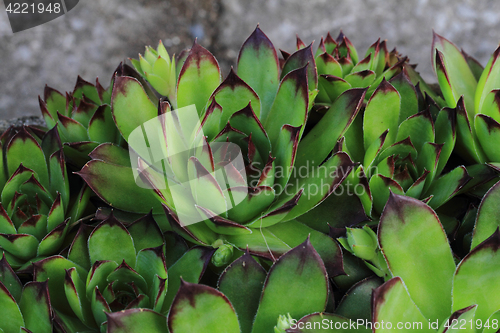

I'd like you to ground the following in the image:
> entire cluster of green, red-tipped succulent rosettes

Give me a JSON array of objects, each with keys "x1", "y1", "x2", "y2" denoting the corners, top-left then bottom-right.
[{"x1": 4, "y1": 27, "x2": 500, "y2": 333}]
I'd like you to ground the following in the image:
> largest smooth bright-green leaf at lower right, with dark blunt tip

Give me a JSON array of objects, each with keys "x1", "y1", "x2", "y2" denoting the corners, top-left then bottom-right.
[{"x1": 378, "y1": 194, "x2": 455, "y2": 321}]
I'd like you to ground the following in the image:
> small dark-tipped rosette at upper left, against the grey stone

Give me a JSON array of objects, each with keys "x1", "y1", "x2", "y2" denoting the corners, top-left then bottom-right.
[{"x1": 38, "y1": 72, "x2": 123, "y2": 167}]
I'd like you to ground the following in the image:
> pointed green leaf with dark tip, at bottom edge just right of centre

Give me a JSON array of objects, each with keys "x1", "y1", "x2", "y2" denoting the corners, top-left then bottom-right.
[{"x1": 252, "y1": 239, "x2": 328, "y2": 332}]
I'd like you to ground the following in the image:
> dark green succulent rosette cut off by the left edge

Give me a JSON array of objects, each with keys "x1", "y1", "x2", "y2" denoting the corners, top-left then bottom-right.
[{"x1": 0, "y1": 127, "x2": 90, "y2": 269}]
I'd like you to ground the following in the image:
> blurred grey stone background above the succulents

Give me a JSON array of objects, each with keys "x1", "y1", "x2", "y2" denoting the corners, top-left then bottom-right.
[{"x1": 0, "y1": 0, "x2": 500, "y2": 122}]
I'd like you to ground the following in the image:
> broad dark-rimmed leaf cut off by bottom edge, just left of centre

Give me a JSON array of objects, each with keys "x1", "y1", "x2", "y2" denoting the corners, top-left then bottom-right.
[{"x1": 168, "y1": 281, "x2": 240, "y2": 333}]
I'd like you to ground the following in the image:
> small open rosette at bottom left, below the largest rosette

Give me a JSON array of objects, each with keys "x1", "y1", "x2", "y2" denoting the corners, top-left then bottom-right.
[{"x1": 33, "y1": 215, "x2": 213, "y2": 332}]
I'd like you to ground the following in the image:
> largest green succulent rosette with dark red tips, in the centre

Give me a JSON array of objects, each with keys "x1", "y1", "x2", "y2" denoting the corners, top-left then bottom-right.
[{"x1": 79, "y1": 28, "x2": 365, "y2": 267}]
